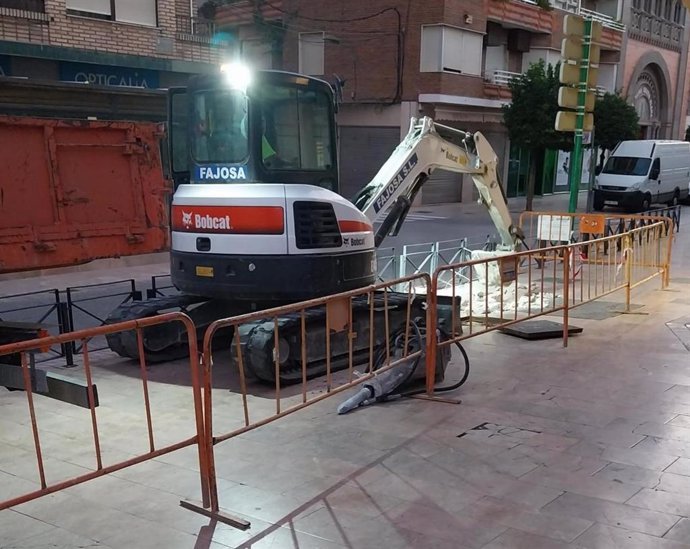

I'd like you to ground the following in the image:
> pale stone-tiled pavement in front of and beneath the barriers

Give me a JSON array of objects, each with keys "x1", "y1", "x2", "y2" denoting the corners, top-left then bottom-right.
[{"x1": 0, "y1": 202, "x2": 690, "y2": 549}]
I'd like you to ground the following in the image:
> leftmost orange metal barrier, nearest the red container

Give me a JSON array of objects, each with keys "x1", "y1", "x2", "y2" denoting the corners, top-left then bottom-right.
[{"x1": 0, "y1": 313, "x2": 210, "y2": 510}]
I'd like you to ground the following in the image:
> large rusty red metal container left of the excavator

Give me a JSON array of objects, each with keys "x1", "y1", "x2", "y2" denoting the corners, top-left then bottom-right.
[{"x1": 0, "y1": 116, "x2": 171, "y2": 273}]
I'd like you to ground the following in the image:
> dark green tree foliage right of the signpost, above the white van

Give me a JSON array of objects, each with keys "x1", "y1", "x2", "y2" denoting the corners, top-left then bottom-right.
[{"x1": 594, "y1": 93, "x2": 640, "y2": 150}]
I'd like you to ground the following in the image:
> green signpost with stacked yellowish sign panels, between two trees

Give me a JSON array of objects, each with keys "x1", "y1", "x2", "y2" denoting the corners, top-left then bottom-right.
[{"x1": 555, "y1": 13, "x2": 600, "y2": 213}]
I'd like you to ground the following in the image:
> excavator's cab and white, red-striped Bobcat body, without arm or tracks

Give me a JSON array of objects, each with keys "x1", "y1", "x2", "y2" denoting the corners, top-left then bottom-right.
[{"x1": 168, "y1": 65, "x2": 376, "y2": 307}]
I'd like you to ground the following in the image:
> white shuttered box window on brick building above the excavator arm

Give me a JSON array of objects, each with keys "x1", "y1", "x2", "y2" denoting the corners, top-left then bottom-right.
[{"x1": 419, "y1": 25, "x2": 483, "y2": 76}]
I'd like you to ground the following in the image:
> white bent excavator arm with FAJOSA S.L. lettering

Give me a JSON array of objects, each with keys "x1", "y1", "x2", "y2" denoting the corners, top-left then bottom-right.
[{"x1": 353, "y1": 117, "x2": 522, "y2": 251}]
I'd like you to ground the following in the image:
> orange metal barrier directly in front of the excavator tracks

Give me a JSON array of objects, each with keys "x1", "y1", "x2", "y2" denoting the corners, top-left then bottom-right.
[{"x1": 203, "y1": 274, "x2": 436, "y2": 529}]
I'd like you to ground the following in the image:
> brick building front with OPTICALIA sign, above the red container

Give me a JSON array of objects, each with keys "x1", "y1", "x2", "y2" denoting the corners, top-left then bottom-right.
[{"x1": 0, "y1": 0, "x2": 229, "y2": 103}]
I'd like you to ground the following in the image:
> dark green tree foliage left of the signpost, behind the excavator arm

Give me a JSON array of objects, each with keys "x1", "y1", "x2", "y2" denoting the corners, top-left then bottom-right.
[{"x1": 503, "y1": 59, "x2": 573, "y2": 151}]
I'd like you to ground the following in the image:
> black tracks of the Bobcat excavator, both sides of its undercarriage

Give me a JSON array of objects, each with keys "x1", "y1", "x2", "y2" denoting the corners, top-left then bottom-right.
[{"x1": 107, "y1": 292, "x2": 456, "y2": 385}]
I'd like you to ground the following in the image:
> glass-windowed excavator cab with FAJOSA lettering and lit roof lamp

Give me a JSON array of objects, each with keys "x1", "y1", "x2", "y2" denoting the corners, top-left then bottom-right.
[{"x1": 168, "y1": 65, "x2": 339, "y2": 193}]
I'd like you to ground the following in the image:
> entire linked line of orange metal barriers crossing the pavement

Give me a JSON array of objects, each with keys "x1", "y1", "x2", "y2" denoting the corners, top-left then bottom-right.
[{"x1": 0, "y1": 214, "x2": 673, "y2": 529}]
